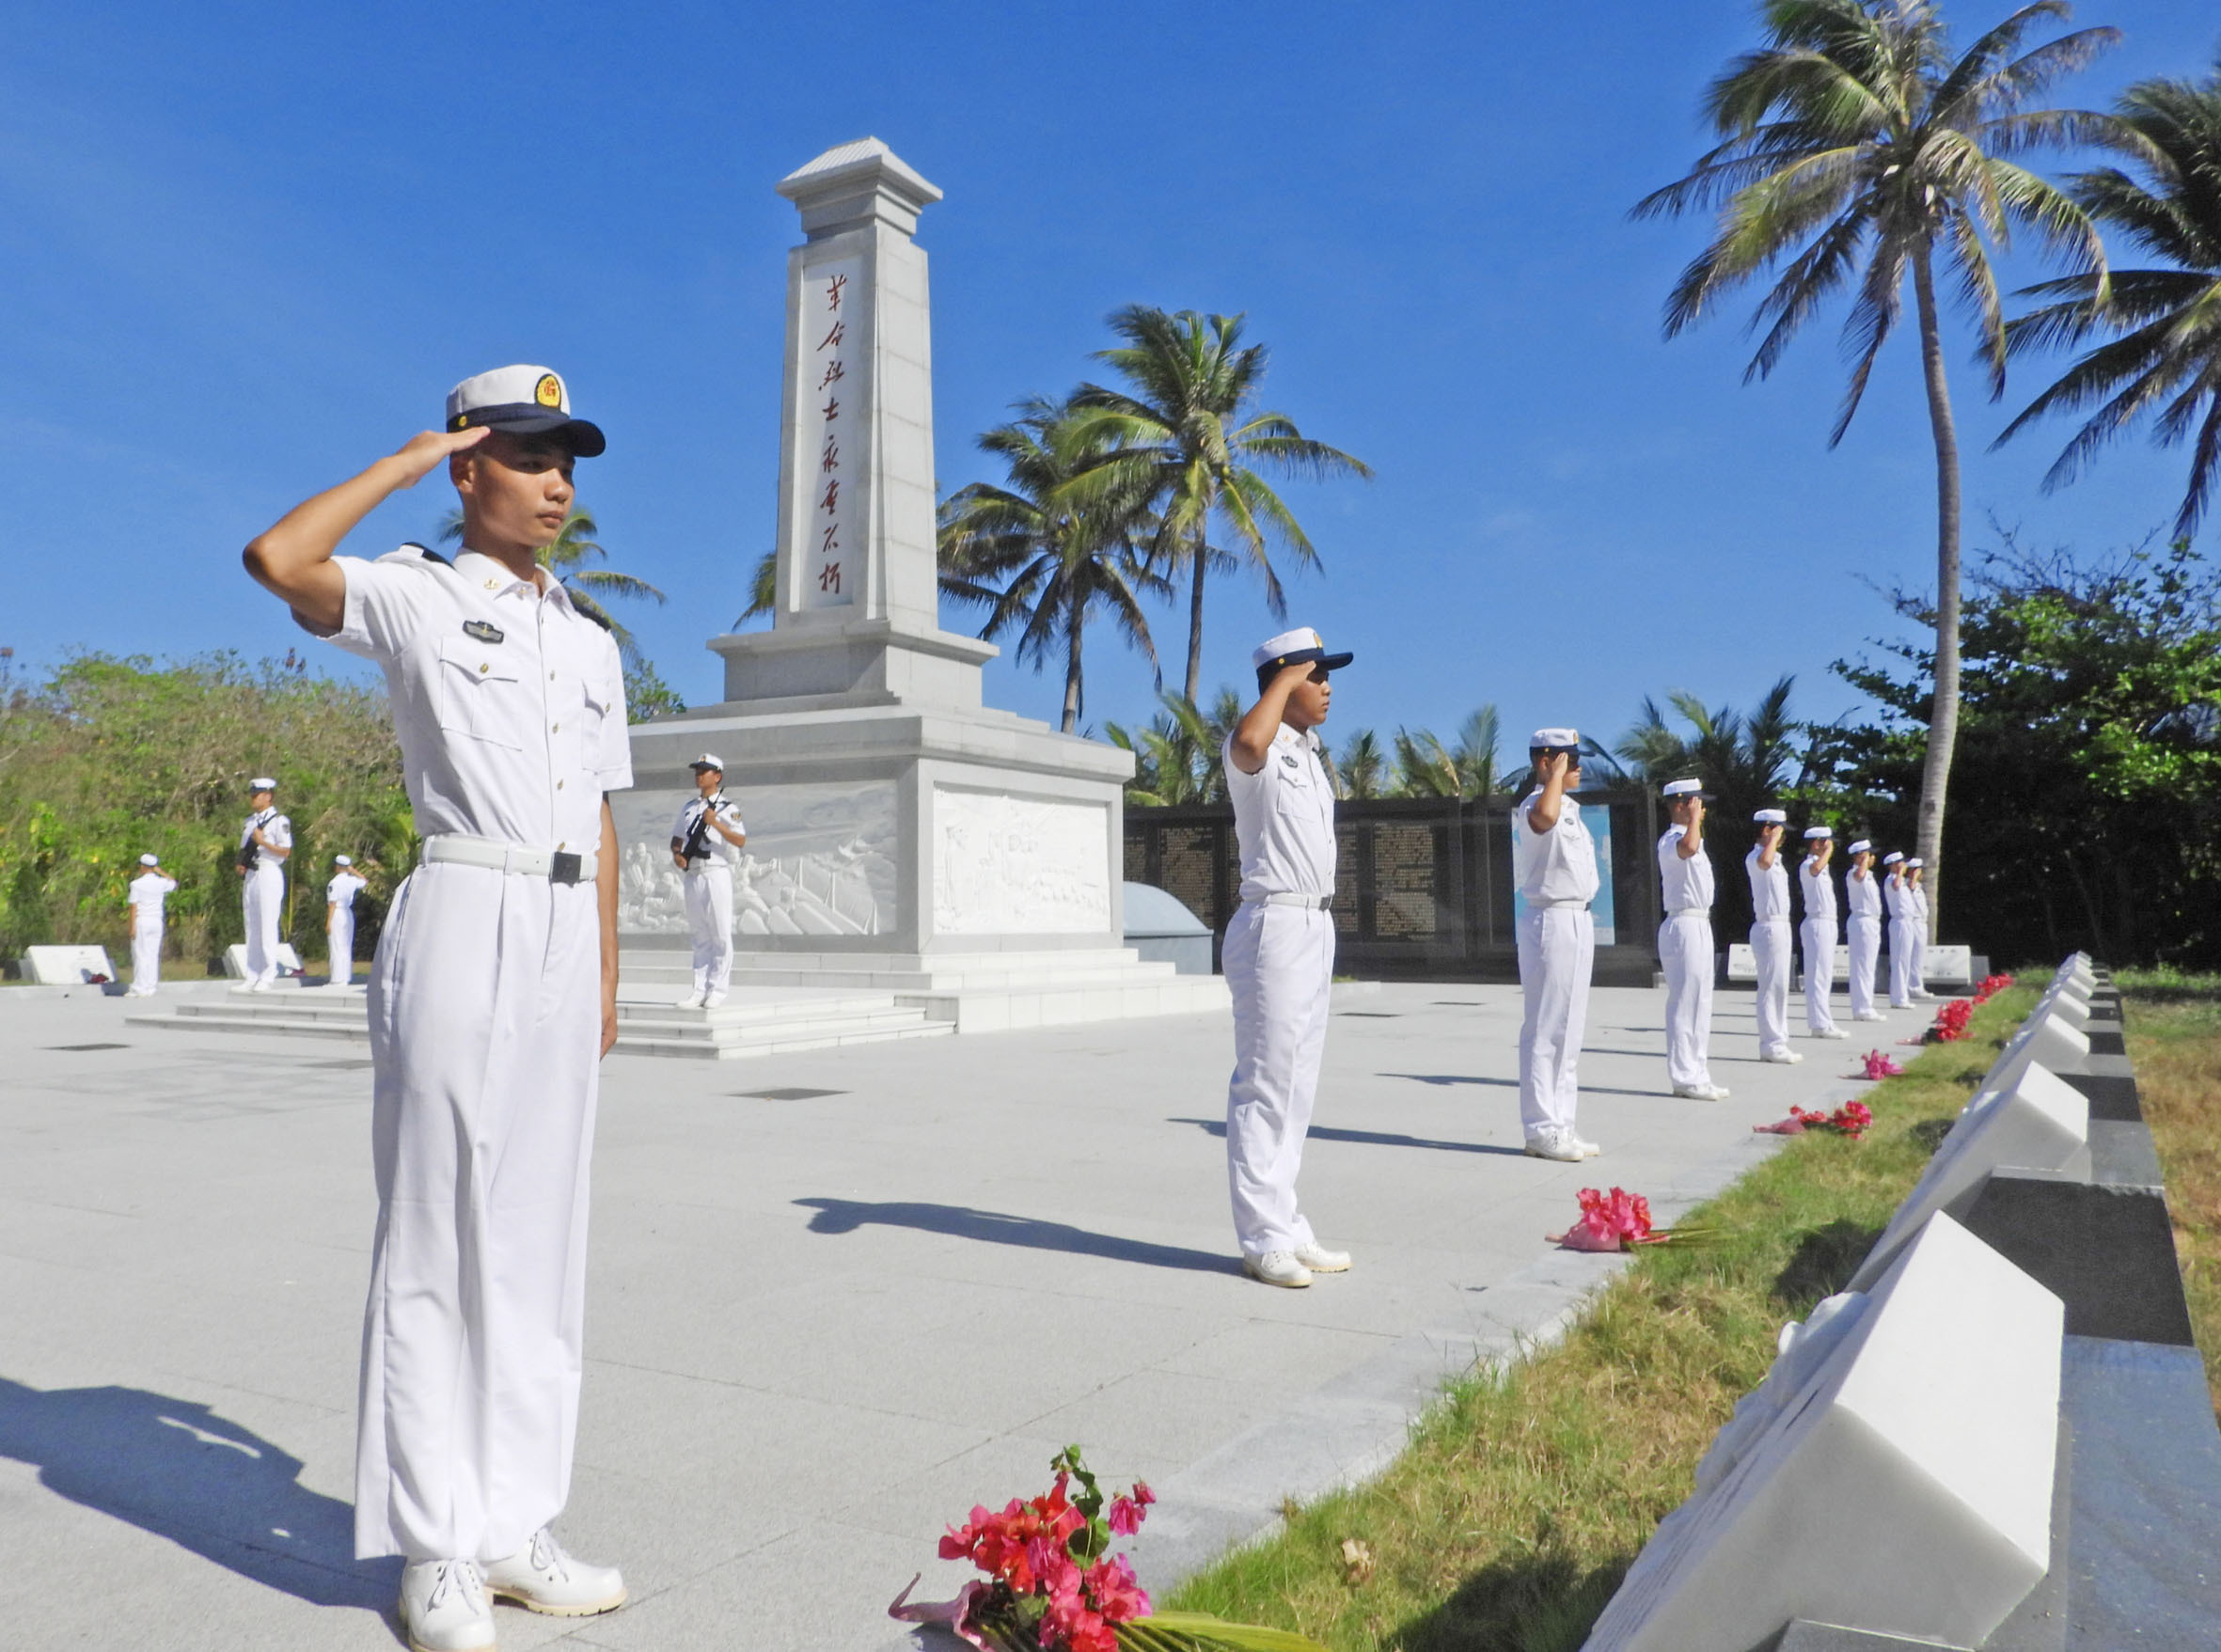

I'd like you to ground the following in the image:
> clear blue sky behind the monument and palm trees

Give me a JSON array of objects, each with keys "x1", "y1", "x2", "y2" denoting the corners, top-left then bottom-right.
[{"x1": 0, "y1": 0, "x2": 2221, "y2": 759}]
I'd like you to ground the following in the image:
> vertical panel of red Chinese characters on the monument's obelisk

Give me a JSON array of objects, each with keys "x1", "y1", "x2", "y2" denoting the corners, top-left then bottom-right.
[{"x1": 795, "y1": 258, "x2": 871, "y2": 608}]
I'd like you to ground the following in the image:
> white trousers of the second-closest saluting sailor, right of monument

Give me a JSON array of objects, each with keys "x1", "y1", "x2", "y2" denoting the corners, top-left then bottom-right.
[{"x1": 1220, "y1": 902, "x2": 1335, "y2": 1257}]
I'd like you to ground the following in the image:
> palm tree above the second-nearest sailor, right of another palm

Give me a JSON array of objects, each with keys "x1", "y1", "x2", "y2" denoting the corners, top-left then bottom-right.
[{"x1": 1070, "y1": 305, "x2": 1373, "y2": 701}]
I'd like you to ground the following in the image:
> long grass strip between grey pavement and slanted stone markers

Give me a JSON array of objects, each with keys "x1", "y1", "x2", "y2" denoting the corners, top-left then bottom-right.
[{"x1": 1166, "y1": 988, "x2": 2035, "y2": 1652}]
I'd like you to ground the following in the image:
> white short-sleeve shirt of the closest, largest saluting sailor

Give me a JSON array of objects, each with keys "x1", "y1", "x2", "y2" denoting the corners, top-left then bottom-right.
[{"x1": 308, "y1": 546, "x2": 633, "y2": 850}]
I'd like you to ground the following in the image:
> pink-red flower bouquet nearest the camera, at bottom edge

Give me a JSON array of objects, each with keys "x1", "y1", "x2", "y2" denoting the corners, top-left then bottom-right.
[{"x1": 886, "y1": 1445, "x2": 1324, "y2": 1652}]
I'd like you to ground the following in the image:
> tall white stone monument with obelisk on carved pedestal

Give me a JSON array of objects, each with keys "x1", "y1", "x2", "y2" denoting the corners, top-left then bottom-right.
[{"x1": 613, "y1": 137, "x2": 1226, "y2": 1031}]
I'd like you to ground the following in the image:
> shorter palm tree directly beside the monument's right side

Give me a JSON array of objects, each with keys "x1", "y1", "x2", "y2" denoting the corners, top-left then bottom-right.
[{"x1": 939, "y1": 395, "x2": 1164, "y2": 735}]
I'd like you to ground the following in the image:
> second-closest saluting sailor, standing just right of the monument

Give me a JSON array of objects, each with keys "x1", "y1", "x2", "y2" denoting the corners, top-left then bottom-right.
[{"x1": 1221, "y1": 626, "x2": 1352, "y2": 1288}]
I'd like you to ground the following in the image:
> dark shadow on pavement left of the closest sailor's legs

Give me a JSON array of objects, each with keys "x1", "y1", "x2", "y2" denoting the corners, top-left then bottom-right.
[{"x1": 0, "y1": 1377, "x2": 400, "y2": 1614}]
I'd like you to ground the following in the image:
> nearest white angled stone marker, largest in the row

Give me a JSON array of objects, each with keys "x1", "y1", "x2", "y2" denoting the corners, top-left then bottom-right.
[{"x1": 1585, "y1": 1215, "x2": 2063, "y2": 1652}]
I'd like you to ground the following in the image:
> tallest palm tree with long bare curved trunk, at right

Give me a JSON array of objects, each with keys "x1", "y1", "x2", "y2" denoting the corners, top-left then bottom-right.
[{"x1": 1634, "y1": 0, "x2": 2119, "y2": 941}]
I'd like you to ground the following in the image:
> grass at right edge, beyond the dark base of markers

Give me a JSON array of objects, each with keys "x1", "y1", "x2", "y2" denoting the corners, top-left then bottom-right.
[{"x1": 2115, "y1": 970, "x2": 2221, "y2": 1412}]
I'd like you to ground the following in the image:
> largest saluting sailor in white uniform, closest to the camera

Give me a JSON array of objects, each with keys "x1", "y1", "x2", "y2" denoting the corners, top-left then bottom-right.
[{"x1": 246, "y1": 367, "x2": 633, "y2": 1652}]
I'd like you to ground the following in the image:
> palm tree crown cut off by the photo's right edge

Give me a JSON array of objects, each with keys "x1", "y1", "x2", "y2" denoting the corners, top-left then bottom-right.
[{"x1": 1996, "y1": 60, "x2": 2221, "y2": 540}]
